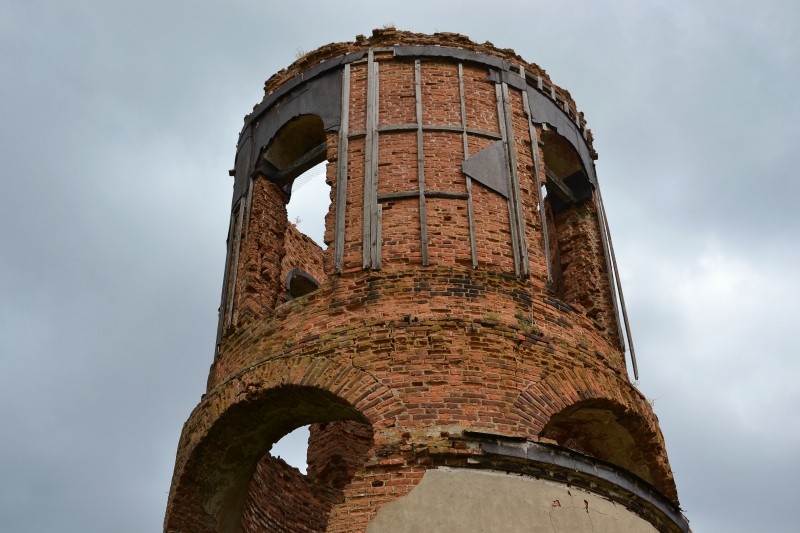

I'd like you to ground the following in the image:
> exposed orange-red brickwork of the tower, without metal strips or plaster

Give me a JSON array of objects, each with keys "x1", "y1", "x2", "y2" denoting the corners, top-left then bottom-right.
[{"x1": 165, "y1": 30, "x2": 677, "y2": 532}]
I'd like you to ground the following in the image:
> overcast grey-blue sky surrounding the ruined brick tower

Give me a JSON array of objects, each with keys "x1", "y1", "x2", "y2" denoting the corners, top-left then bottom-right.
[{"x1": 0, "y1": 0, "x2": 800, "y2": 533}]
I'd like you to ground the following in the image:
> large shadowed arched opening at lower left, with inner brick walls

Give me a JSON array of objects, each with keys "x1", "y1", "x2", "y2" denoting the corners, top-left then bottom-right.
[{"x1": 185, "y1": 385, "x2": 372, "y2": 533}]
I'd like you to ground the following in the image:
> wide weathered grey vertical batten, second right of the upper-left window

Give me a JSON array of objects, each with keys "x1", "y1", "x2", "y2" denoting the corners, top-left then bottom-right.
[{"x1": 362, "y1": 49, "x2": 380, "y2": 268}]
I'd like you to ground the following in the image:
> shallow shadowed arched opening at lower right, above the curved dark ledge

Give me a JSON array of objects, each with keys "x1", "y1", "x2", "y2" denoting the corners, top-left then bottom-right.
[{"x1": 539, "y1": 399, "x2": 657, "y2": 485}]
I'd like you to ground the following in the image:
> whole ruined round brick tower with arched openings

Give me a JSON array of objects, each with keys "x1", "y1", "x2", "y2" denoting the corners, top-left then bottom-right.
[{"x1": 164, "y1": 29, "x2": 688, "y2": 533}]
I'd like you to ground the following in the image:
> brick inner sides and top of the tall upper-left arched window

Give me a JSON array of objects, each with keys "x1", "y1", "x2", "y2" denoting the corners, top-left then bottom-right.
[{"x1": 231, "y1": 111, "x2": 337, "y2": 324}]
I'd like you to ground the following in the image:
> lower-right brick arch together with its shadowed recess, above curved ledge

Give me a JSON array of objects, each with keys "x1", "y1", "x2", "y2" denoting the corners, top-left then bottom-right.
[{"x1": 512, "y1": 368, "x2": 677, "y2": 502}]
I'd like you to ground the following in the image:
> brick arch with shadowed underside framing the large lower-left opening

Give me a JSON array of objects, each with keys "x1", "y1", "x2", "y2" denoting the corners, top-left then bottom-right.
[{"x1": 165, "y1": 357, "x2": 404, "y2": 533}]
